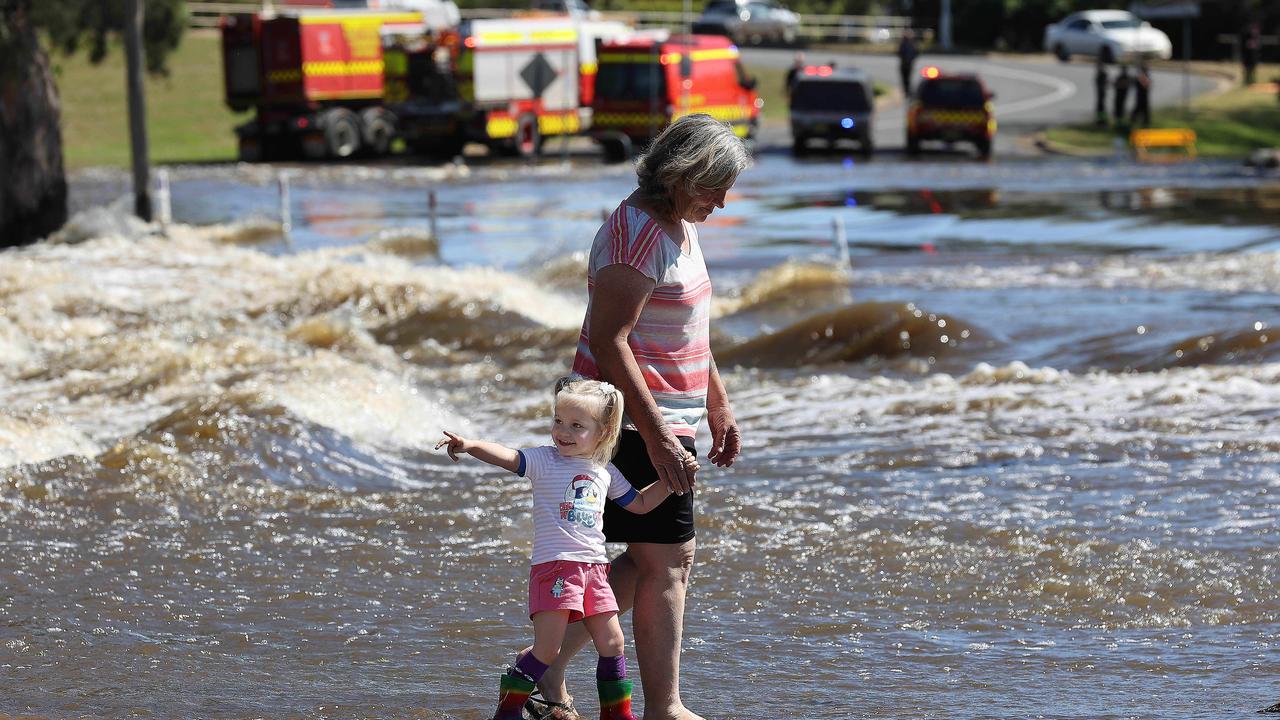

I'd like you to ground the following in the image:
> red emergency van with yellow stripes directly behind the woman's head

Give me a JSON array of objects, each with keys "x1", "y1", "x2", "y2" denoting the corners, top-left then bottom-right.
[{"x1": 591, "y1": 35, "x2": 764, "y2": 160}]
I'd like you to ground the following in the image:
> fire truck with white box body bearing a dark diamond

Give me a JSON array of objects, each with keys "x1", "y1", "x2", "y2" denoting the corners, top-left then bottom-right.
[{"x1": 383, "y1": 15, "x2": 632, "y2": 158}]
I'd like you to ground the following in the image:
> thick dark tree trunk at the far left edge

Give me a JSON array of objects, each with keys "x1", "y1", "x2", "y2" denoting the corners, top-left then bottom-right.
[{"x1": 0, "y1": 4, "x2": 67, "y2": 246}]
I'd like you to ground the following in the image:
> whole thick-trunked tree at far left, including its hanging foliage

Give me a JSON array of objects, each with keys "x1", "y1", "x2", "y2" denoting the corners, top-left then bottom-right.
[{"x1": 0, "y1": 0, "x2": 186, "y2": 246}]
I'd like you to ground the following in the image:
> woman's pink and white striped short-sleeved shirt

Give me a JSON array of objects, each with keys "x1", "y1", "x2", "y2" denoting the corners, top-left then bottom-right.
[{"x1": 573, "y1": 202, "x2": 712, "y2": 437}]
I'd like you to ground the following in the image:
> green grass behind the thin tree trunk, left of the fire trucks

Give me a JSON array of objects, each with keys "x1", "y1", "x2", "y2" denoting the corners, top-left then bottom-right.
[{"x1": 52, "y1": 32, "x2": 248, "y2": 168}]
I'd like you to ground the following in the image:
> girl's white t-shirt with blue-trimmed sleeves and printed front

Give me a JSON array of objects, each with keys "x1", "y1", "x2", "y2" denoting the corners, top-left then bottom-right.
[{"x1": 517, "y1": 446, "x2": 636, "y2": 565}]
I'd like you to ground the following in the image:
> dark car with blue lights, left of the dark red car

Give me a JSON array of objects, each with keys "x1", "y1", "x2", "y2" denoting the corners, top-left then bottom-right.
[{"x1": 791, "y1": 65, "x2": 876, "y2": 155}]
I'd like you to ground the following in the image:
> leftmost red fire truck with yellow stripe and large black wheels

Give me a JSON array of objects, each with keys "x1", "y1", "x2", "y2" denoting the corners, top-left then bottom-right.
[{"x1": 221, "y1": 0, "x2": 460, "y2": 161}]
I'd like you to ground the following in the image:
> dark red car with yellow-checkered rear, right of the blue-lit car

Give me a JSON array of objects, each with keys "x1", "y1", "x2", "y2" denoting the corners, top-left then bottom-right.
[{"x1": 906, "y1": 67, "x2": 996, "y2": 159}]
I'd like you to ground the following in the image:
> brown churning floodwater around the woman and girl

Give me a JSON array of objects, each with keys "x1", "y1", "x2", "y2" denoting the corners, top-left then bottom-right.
[{"x1": 0, "y1": 155, "x2": 1280, "y2": 720}]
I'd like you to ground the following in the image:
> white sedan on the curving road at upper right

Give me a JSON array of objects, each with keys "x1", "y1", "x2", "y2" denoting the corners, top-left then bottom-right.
[{"x1": 1044, "y1": 10, "x2": 1174, "y2": 63}]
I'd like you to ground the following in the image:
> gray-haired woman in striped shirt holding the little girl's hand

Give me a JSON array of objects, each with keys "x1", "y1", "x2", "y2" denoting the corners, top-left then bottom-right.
[{"x1": 527, "y1": 114, "x2": 751, "y2": 720}]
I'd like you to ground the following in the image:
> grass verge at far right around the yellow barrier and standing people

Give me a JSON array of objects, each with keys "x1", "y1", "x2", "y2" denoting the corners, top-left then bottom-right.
[{"x1": 1046, "y1": 64, "x2": 1280, "y2": 158}]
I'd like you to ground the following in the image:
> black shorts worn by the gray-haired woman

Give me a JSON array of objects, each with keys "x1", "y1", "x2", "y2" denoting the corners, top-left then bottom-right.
[{"x1": 604, "y1": 430, "x2": 698, "y2": 544}]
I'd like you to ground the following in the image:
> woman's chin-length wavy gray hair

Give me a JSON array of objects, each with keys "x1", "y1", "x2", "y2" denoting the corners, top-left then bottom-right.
[{"x1": 636, "y1": 113, "x2": 751, "y2": 213}]
